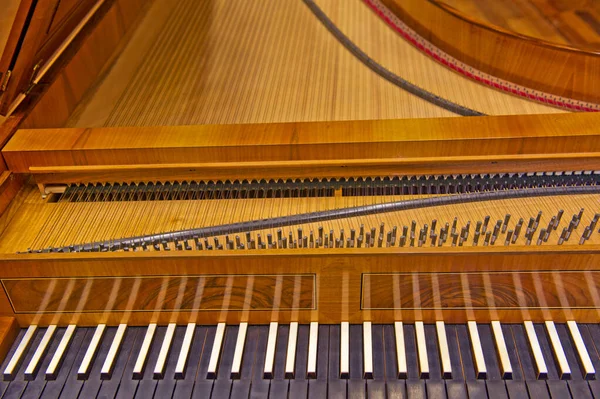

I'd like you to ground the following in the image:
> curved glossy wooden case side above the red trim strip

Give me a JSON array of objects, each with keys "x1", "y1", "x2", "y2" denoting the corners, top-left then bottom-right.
[{"x1": 383, "y1": 0, "x2": 600, "y2": 103}]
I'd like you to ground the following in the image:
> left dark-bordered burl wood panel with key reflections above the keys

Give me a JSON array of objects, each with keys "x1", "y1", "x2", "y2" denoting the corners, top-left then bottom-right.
[{"x1": 2, "y1": 275, "x2": 316, "y2": 314}]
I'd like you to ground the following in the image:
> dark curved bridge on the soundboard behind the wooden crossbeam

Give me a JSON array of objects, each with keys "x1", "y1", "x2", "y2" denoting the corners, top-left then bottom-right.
[{"x1": 303, "y1": 0, "x2": 486, "y2": 116}]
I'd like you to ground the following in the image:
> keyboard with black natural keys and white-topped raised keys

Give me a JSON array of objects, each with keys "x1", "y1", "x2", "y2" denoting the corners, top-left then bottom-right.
[{"x1": 0, "y1": 321, "x2": 600, "y2": 399}]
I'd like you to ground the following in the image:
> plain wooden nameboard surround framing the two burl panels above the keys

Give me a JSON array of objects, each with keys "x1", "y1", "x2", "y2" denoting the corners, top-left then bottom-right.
[{"x1": 0, "y1": 250, "x2": 600, "y2": 326}]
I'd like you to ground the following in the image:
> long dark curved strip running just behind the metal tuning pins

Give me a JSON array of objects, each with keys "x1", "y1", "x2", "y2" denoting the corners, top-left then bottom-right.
[{"x1": 38, "y1": 185, "x2": 600, "y2": 252}]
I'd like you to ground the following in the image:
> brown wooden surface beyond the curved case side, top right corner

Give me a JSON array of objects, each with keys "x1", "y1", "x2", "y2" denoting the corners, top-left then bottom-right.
[{"x1": 438, "y1": 0, "x2": 600, "y2": 50}]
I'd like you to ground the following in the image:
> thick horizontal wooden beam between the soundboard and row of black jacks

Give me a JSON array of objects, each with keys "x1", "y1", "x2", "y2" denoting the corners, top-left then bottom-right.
[{"x1": 2, "y1": 114, "x2": 600, "y2": 173}]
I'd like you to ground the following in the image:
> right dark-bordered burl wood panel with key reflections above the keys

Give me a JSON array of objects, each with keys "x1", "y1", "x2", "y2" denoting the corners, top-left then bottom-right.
[{"x1": 362, "y1": 271, "x2": 600, "y2": 310}]
